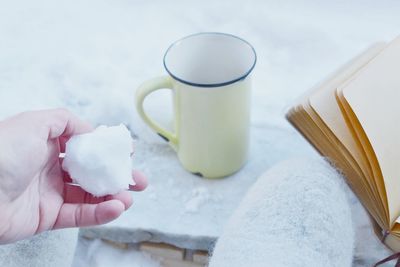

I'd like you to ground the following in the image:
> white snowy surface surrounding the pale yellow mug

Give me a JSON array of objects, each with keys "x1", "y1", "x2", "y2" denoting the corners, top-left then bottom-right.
[{"x1": 0, "y1": 0, "x2": 400, "y2": 266}]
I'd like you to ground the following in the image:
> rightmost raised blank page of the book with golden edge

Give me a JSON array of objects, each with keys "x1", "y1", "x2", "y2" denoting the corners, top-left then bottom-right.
[{"x1": 339, "y1": 38, "x2": 400, "y2": 225}]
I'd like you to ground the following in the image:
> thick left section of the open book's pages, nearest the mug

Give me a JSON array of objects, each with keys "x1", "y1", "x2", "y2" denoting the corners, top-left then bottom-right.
[{"x1": 286, "y1": 43, "x2": 389, "y2": 229}]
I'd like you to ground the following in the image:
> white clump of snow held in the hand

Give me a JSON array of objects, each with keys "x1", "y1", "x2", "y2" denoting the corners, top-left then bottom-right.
[{"x1": 62, "y1": 124, "x2": 134, "y2": 197}]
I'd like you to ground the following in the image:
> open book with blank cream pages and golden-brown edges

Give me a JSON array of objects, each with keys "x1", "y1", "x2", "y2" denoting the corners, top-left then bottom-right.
[{"x1": 287, "y1": 37, "x2": 400, "y2": 251}]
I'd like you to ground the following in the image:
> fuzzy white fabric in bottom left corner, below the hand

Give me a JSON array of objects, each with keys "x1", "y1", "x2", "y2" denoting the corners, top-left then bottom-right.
[{"x1": 0, "y1": 229, "x2": 78, "y2": 267}]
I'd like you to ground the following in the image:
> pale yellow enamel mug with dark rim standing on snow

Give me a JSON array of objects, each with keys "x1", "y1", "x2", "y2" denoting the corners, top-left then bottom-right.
[{"x1": 136, "y1": 32, "x2": 257, "y2": 178}]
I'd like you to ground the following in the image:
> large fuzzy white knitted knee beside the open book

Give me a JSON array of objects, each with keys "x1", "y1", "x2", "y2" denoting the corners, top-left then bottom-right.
[{"x1": 210, "y1": 159, "x2": 354, "y2": 267}]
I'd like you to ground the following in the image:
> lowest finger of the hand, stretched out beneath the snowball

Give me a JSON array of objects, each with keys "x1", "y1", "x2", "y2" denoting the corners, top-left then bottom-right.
[{"x1": 53, "y1": 199, "x2": 125, "y2": 229}]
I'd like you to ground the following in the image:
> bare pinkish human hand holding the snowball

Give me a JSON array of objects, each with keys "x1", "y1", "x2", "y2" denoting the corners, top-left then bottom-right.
[{"x1": 0, "y1": 109, "x2": 147, "y2": 244}]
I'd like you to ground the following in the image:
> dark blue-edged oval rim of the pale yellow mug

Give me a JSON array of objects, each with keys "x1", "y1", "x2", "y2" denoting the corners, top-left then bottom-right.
[{"x1": 163, "y1": 32, "x2": 257, "y2": 87}]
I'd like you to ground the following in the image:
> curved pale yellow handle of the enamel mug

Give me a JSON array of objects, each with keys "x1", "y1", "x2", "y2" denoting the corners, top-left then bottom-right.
[{"x1": 135, "y1": 76, "x2": 178, "y2": 150}]
